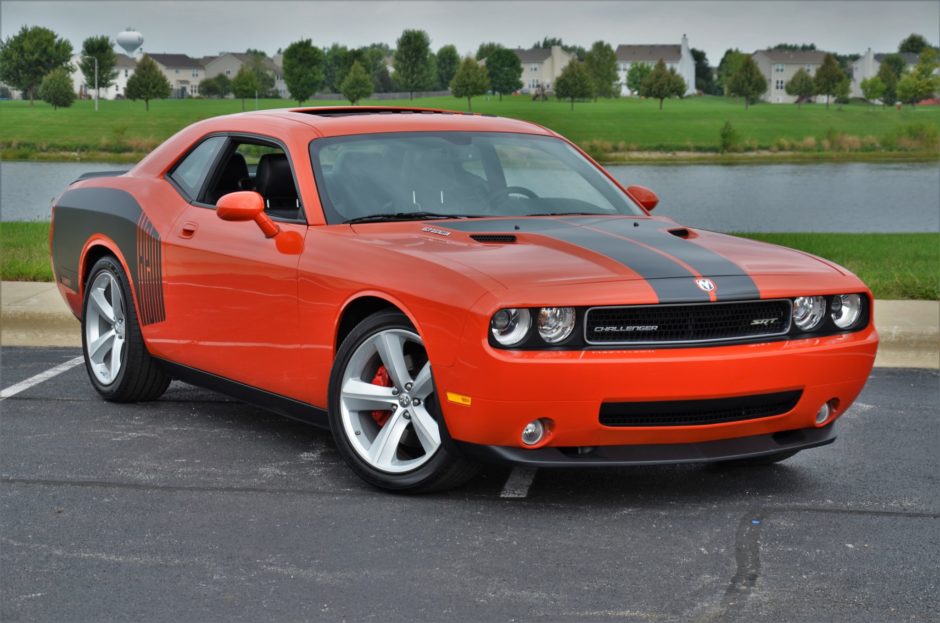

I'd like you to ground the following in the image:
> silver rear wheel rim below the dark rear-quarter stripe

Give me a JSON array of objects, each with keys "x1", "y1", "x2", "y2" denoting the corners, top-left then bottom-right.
[{"x1": 85, "y1": 271, "x2": 127, "y2": 385}]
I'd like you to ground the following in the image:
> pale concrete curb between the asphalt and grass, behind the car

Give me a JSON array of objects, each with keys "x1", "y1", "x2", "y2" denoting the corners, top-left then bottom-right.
[{"x1": 0, "y1": 281, "x2": 940, "y2": 369}]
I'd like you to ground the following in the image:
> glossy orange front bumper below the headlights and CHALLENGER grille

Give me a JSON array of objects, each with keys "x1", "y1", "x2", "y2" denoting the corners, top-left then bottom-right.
[{"x1": 434, "y1": 325, "x2": 878, "y2": 450}]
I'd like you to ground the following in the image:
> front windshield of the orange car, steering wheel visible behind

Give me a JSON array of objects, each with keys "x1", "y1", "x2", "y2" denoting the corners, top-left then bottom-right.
[{"x1": 310, "y1": 132, "x2": 643, "y2": 223}]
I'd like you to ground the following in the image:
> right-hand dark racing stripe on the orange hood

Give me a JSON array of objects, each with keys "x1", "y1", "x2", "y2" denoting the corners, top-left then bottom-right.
[{"x1": 572, "y1": 218, "x2": 760, "y2": 301}]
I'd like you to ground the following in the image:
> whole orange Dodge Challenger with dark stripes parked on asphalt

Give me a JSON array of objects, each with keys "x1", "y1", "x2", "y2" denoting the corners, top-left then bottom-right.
[{"x1": 50, "y1": 107, "x2": 878, "y2": 492}]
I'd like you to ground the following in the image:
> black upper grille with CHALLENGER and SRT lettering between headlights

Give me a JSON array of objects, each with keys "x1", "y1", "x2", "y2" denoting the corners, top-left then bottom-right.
[{"x1": 584, "y1": 299, "x2": 791, "y2": 345}]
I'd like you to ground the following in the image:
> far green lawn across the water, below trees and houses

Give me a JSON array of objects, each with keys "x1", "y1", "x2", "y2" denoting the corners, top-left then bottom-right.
[{"x1": 0, "y1": 96, "x2": 940, "y2": 159}]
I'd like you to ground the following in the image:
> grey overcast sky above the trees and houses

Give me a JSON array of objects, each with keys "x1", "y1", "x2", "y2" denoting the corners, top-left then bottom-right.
[{"x1": 0, "y1": 0, "x2": 940, "y2": 65}]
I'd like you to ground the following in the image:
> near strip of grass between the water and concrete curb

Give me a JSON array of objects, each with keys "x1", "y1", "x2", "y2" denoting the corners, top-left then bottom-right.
[{"x1": 0, "y1": 222, "x2": 940, "y2": 300}]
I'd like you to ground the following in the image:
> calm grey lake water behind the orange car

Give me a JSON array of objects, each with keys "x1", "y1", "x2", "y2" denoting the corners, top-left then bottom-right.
[{"x1": 0, "y1": 162, "x2": 940, "y2": 232}]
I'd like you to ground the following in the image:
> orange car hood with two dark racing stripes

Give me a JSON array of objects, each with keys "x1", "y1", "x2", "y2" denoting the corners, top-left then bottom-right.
[{"x1": 346, "y1": 216, "x2": 840, "y2": 301}]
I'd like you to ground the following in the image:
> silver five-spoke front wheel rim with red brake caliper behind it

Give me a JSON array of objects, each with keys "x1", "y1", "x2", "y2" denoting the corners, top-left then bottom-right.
[{"x1": 339, "y1": 329, "x2": 441, "y2": 474}]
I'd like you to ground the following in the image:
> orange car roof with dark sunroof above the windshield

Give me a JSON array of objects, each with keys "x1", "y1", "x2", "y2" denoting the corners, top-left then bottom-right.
[{"x1": 242, "y1": 106, "x2": 554, "y2": 137}]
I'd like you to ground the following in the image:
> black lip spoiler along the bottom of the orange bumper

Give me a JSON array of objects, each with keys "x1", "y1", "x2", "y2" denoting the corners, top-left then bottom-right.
[{"x1": 460, "y1": 424, "x2": 836, "y2": 467}]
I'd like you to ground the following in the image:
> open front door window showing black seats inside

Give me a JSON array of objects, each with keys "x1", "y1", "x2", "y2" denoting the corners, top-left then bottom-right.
[{"x1": 205, "y1": 137, "x2": 303, "y2": 220}]
